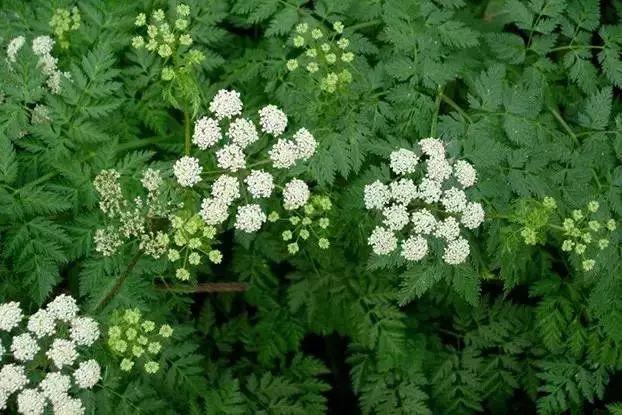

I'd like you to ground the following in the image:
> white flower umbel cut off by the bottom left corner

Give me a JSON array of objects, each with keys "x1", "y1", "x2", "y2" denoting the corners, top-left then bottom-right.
[{"x1": 0, "y1": 294, "x2": 101, "y2": 415}]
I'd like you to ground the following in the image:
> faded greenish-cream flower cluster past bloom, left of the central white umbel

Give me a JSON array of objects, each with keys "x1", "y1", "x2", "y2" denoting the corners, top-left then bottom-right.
[{"x1": 93, "y1": 168, "x2": 171, "y2": 258}]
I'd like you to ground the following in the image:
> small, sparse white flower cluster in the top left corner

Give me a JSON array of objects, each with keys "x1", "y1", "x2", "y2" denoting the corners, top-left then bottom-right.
[{"x1": 6, "y1": 36, "x2": 70, "y2": 94}]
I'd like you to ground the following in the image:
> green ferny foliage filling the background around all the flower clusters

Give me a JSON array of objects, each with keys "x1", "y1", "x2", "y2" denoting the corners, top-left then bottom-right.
[{"x1": 0, "y1": 0, "x2": 622, "y2": 415}]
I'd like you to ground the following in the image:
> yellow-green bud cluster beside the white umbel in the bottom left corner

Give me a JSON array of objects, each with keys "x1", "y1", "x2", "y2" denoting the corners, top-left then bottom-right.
[{"x1": 107, "y1": 308, "x2": 173, "y2": 374}]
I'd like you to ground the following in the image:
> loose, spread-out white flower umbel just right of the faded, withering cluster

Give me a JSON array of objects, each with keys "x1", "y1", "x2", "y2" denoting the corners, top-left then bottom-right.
[{"x1": 173, "y1": 89, "x2": 317, "y2": 239}]
